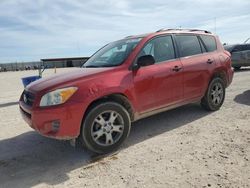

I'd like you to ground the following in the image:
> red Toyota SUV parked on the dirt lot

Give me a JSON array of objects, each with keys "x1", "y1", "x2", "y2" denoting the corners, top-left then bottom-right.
[{"x1": 20, "y1": 29, "x2": 233, "y2": 153}]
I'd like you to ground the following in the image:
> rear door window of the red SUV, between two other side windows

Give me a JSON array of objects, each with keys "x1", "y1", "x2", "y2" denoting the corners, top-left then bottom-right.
[{"x1": 176, "y1": 35, "x2": 202, "y2": 57}]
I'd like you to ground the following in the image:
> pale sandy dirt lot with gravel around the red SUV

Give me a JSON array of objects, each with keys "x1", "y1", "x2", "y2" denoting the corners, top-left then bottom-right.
[{"x1": 0, "y1": 69, "x2": 250, "y2": 188}]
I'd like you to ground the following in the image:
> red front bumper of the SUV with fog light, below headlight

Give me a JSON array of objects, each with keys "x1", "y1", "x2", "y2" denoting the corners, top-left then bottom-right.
[{"x1": 19, "y1": 101, "x2": 83, "y2": 140}]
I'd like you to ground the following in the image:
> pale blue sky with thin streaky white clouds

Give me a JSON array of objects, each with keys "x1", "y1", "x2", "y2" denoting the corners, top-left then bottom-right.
[{"x1": 0, "y1": 0, "x2": 250, "y2": 63}]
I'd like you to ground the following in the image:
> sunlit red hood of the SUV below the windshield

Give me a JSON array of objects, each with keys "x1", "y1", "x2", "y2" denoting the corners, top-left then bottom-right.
[{"x1": 26, "y1": 68, "x2": 112, "y2": 92}]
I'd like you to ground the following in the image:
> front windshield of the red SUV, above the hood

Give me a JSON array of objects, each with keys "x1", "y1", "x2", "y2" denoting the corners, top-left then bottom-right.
[{"x1": 83, "y1": 38, "x2": 142, "y2": 68}]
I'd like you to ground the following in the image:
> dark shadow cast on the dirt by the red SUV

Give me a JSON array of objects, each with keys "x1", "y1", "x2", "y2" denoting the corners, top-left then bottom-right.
[{"x1": 0, "y1": 104, "x2": 210, "y2": 187}]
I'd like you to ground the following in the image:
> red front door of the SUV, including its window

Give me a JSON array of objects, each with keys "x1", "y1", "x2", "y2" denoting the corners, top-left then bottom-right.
[{"x1": 133, "y1": 35, "x2": 183, "y2": 113}]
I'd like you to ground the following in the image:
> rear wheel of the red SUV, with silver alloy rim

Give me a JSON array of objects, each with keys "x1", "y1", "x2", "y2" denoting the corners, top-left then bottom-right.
[{"x1": 201, "y1": 77, "x2": 226, "y2": 111}]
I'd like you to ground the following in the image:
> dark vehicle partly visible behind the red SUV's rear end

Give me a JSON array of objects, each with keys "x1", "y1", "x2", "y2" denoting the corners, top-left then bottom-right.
[{"x1": 224, "y1": 43, "x2": 250, "y2": 70}]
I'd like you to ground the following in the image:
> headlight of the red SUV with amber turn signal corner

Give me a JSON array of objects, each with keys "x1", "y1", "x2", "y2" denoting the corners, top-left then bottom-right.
[{"x1": 40, "y1": 87, "x2": 77, "y2": 107}]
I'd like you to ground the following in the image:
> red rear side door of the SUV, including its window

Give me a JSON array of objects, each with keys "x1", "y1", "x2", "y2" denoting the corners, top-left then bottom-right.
[{"x1": 176, "y1": 34, "x2": 215, "y2": 100}]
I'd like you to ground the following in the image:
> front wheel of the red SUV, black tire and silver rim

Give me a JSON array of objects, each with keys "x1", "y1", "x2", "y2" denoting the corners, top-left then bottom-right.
[{"x1": 81, "y1": 102, "x2": 131, "y2": 154}]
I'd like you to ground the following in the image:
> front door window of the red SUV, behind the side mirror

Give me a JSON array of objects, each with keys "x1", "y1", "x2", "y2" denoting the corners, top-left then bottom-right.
[{"x1": 139, "y1": 36, "x2": 175, "y2": 63}]
